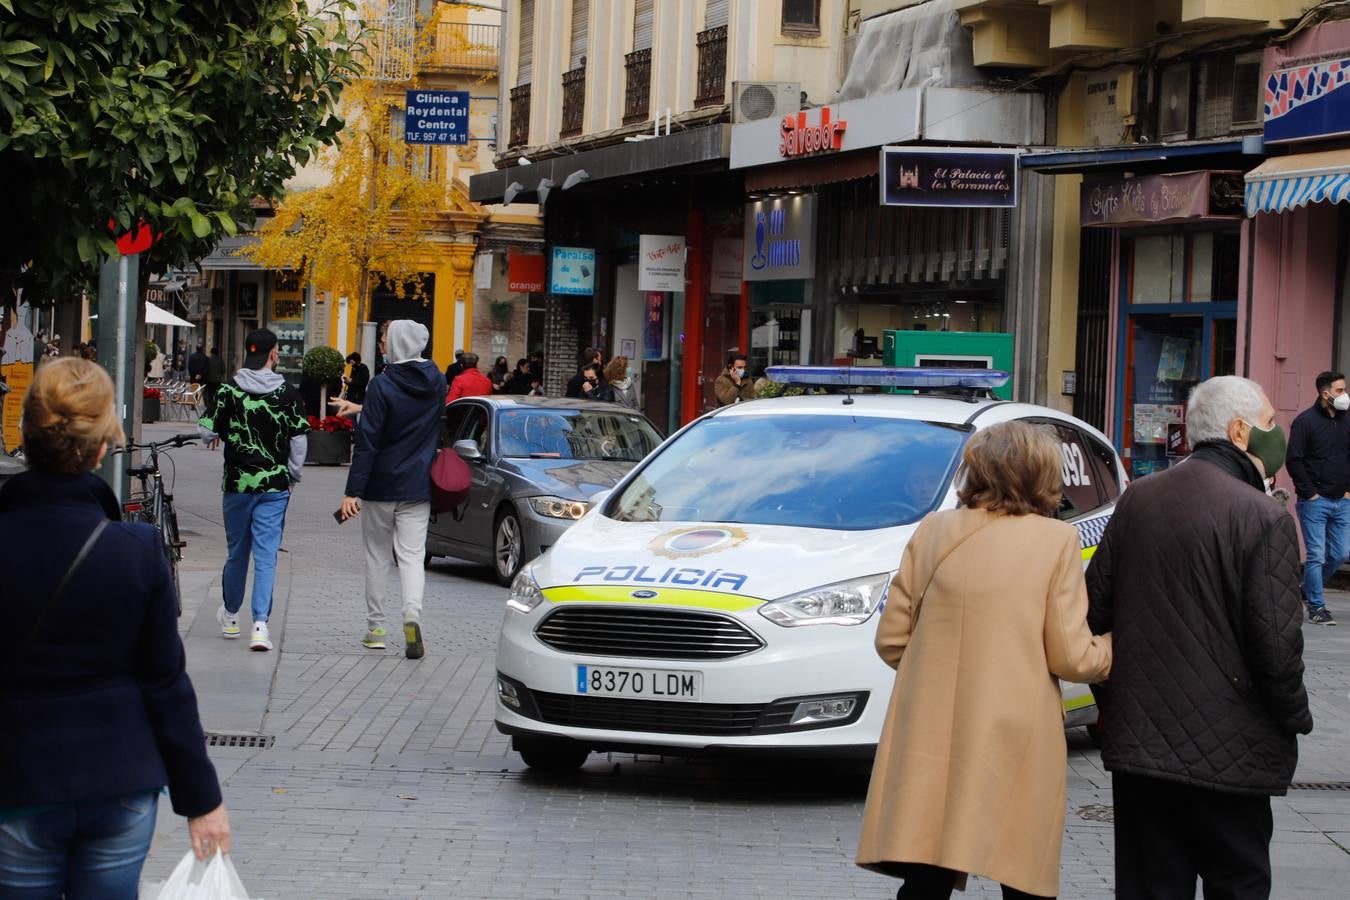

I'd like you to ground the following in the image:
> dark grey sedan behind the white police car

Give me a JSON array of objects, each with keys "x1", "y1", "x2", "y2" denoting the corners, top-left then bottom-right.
[{"x1": 427, "y1": 397, "x2": 662, "y2": 584}]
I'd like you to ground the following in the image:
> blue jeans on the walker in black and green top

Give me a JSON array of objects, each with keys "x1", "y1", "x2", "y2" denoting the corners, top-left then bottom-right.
[{"x1": 221, "y1": 491, "x2": 290, "y2": 622}]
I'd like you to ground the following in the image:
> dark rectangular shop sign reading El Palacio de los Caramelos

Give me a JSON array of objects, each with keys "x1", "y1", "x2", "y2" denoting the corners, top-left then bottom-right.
[{"x1": 882, "y1": 147, "x2": 1018, "y2": 206}]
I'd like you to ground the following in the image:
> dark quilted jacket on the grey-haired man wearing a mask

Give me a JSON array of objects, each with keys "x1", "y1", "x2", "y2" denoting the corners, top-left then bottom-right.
[{"x1": 1087, "y1": 441, "x2": 1312, "y2": 795}]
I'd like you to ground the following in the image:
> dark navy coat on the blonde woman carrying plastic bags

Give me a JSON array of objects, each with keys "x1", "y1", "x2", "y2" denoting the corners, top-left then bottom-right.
[{"x1": 0, "y1": 472, "x2": 220, "y2": 816}]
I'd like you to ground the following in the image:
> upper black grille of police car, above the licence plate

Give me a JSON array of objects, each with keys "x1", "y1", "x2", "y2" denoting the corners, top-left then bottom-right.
[{"x1": 535, "y1": 606, "x2": 764, "y2": 660}]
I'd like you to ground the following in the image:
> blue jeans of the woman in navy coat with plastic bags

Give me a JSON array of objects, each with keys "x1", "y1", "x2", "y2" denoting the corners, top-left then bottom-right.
[{"x1": 0, "y1": 791, "x2": 159, "y2": 900}]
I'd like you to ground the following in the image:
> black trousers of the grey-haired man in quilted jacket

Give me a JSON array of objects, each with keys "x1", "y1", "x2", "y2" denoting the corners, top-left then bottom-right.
[{"x1": 1111, "y1": 772, "x2": 1274, "y2": 900}]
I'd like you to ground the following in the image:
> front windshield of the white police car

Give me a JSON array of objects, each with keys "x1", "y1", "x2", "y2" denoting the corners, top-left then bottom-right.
[{"x1": 610, "y1": 414, "x2": 971, "y2": 530}]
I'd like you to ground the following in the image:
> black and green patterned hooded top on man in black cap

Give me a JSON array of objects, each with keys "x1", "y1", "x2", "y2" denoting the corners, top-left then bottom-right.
[{"x1": 197, "y1": 368, "x2": 309, "y2": 494}]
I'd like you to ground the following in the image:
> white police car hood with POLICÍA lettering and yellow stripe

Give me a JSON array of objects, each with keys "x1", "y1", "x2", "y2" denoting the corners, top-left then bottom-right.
[{"x1": 532, "y1": 511, "x2": 917, "y2": 609}]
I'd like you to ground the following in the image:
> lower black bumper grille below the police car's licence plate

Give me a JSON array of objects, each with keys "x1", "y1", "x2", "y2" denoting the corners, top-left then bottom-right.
[{"x1": 535, "y1": 691, "x2": 782, "y2": 735}]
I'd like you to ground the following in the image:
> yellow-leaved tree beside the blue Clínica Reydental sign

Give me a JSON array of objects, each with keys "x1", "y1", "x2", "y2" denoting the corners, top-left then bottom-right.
[{"x1": 248, "y1": 66, "x2": 446, "y2": 330}]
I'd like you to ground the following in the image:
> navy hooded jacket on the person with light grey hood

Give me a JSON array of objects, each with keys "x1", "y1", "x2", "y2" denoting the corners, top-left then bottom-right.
[{"x1": 347, "y1": 359, "x2": 446, "y2": 501}]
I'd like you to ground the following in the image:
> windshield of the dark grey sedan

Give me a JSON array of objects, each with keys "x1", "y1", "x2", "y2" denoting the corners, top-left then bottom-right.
[{"x1": 498, "y1": 409, "x2": 662, "y2": 463}]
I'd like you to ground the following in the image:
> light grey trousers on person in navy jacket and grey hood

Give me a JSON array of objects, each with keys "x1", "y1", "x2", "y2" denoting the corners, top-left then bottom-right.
[{"x1": 360, "y1": 501, "x2": 431, "y2": 629}]
